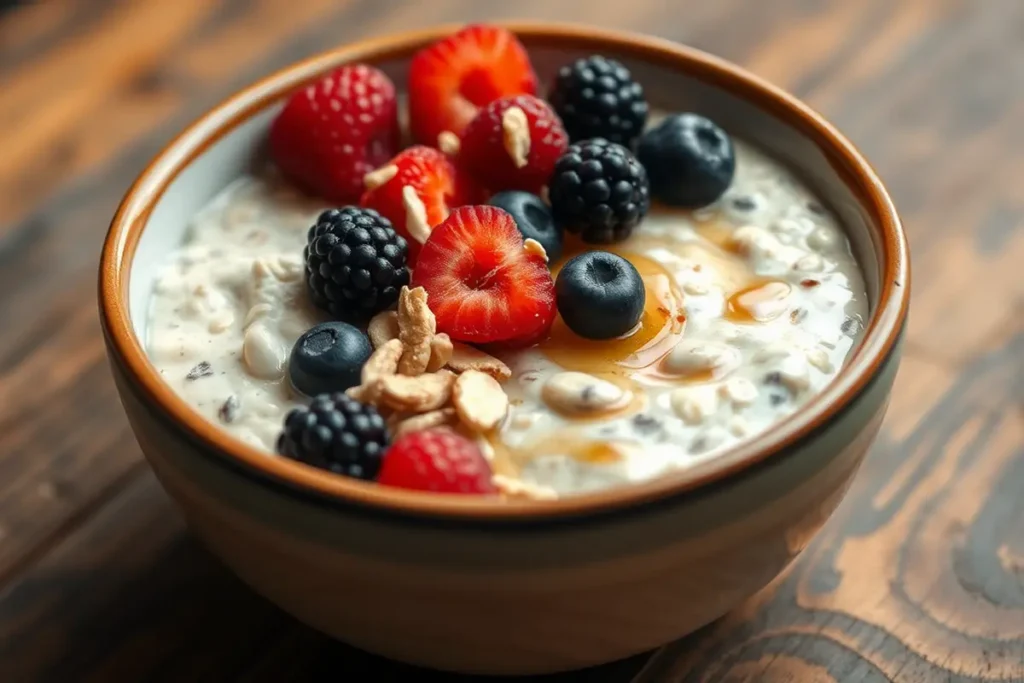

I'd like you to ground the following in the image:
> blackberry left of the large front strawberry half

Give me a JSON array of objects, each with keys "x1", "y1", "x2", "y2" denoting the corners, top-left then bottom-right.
[{"x1": 302, "y1": 206, "x2": 409, "y2": 323}]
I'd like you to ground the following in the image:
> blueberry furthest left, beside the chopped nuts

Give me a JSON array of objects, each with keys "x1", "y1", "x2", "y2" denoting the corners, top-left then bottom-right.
[{"x1": 288, "y1": 323, "x2": 373, "y2": 396}]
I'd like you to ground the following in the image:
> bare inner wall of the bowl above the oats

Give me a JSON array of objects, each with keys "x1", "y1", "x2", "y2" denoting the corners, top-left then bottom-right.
[{"x1": 129, "y1": 41, "x2": 881, "y2": 344}]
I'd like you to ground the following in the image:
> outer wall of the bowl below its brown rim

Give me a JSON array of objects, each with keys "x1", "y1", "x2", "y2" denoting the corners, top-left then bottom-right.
[{"x1": 103, "y1": 335, "x2": 897, "y2": 675}]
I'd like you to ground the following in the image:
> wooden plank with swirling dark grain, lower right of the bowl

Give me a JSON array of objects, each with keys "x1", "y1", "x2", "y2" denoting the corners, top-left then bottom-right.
[{"x1": 638, "y1": 325, "x2": 1024, "y2": 683}]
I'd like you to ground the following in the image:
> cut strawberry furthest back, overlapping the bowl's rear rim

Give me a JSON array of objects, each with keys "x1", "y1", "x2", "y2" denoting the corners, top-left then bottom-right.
[{"x1": 409, "y1": 25, "x2": 537, "y2": 144}]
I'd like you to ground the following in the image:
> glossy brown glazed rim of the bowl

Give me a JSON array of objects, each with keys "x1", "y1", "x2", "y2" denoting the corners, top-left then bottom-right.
[{"x1": 99, "y1": 24, "x2": 909, "y2": 522}]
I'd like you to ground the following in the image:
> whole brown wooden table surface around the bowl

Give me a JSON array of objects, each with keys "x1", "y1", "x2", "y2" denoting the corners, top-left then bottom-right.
[{"x1": 0, "y1": 0, "x2": 1024, "y2": 683}]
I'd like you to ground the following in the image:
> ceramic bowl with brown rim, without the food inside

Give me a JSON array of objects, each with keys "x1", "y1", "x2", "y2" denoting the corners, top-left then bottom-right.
[{"x1": 99, "y1": 25, "x2": 909, "y2": 674}]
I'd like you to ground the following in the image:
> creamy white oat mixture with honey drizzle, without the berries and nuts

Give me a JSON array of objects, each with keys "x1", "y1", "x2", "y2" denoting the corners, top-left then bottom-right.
[{"x1": 147, "y1": 141, "x2": 867, "y2": 495}]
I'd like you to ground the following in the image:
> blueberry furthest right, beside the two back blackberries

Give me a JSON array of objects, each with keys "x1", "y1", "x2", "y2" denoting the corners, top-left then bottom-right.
[{"x1": 637, "y1": 114, "x2": 736, "y2": 209}]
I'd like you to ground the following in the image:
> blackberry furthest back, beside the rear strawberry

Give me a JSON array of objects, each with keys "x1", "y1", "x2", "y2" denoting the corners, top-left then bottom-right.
[{"x1": 548, "y1": 54, "x2": 648, "y2": 146}]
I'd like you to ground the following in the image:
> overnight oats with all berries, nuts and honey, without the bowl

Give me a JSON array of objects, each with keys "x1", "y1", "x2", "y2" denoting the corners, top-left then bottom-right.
[{"x1": 147, "y1": 26, "x2": 867, "y2": 499}]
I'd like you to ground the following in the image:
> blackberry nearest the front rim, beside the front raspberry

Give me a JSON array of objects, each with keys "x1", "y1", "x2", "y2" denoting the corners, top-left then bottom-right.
[{"x1": 278, "y1": 393, "x2": 388, "y2": 479}]
